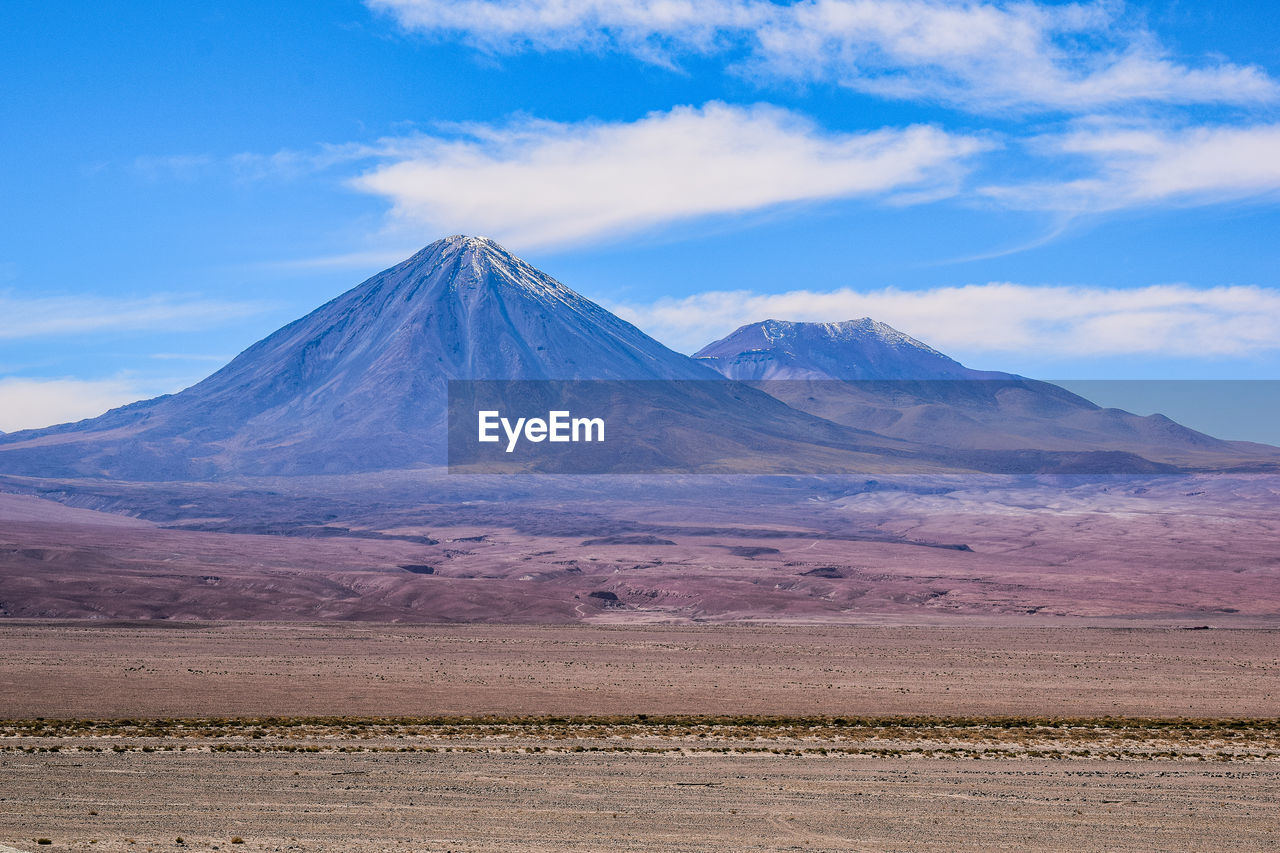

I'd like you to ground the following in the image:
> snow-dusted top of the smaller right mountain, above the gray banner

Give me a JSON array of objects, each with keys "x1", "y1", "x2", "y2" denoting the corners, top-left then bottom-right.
[{"x1": 694, "y1": 318, "x2": 983, "y2": 379}]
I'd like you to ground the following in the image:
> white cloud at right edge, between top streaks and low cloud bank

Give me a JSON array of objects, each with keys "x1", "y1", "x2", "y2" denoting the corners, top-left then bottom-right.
[{"x1": 980, "y1": 122, "x2": 1280, "y2": 213}]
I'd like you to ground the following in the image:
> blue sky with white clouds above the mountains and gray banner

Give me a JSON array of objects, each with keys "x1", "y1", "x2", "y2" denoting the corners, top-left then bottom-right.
[{"x1": 0, "y1": 0, "x2": 1280, "y2": 430}]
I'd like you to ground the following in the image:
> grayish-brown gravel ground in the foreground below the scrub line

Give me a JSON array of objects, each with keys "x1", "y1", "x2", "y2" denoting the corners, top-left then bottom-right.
[{"x1": 0, "y1": 752, "x2": 1280, "y2": 853}]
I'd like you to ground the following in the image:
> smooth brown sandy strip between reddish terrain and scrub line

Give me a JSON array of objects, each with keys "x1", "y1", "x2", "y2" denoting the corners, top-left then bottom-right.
[{"x1": 0, "y1": 620, "x2": 1280, "y2": 719}]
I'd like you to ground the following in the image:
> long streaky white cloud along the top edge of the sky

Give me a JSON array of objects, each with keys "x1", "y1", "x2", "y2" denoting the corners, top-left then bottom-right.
[{"x1": 366, "y1": 0, "x2": 1277, "y2": 111}]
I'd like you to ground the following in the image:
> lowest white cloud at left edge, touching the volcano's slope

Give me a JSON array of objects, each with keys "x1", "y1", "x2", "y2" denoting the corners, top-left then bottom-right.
[{"x1": 0, "y1": 377, "x2": 162, "y2": 433}]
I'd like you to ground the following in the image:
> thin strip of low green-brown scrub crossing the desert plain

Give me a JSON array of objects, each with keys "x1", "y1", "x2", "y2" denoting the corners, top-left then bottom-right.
[{"x1": 0, "y1": 715, "x2": 1280, "y2": 762}]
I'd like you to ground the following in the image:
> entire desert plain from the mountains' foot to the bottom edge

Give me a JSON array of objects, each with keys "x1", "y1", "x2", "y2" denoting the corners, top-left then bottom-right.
[{"x1": 0, "y1": 474, "x2": 1280, "y2": 853}]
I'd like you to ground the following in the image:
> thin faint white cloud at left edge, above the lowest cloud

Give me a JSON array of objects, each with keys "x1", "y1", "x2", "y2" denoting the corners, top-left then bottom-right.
[{"x1": 0, "y1": 293, "x2": 266, "y2": 339}]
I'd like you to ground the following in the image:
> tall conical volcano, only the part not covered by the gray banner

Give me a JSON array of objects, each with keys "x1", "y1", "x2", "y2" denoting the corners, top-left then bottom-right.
[{"x1": 0, "y1": 236, "x2": 721, "y2": 480}]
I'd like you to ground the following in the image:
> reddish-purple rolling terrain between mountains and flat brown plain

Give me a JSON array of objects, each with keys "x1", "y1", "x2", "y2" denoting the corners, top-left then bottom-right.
[{"x1": 0, "y1": 475, "x2": 1280, "y2": 625}]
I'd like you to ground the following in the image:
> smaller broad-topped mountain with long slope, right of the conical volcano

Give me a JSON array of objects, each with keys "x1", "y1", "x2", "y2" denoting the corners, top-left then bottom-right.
[{"x1": 694, "y1": 318, "x2": 1280, "y2": 466}]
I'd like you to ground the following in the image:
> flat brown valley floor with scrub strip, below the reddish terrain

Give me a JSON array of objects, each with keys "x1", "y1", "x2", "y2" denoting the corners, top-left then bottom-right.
[{"x1": 0, "y1": 620, "x2": 1280, "y2": 852}]
